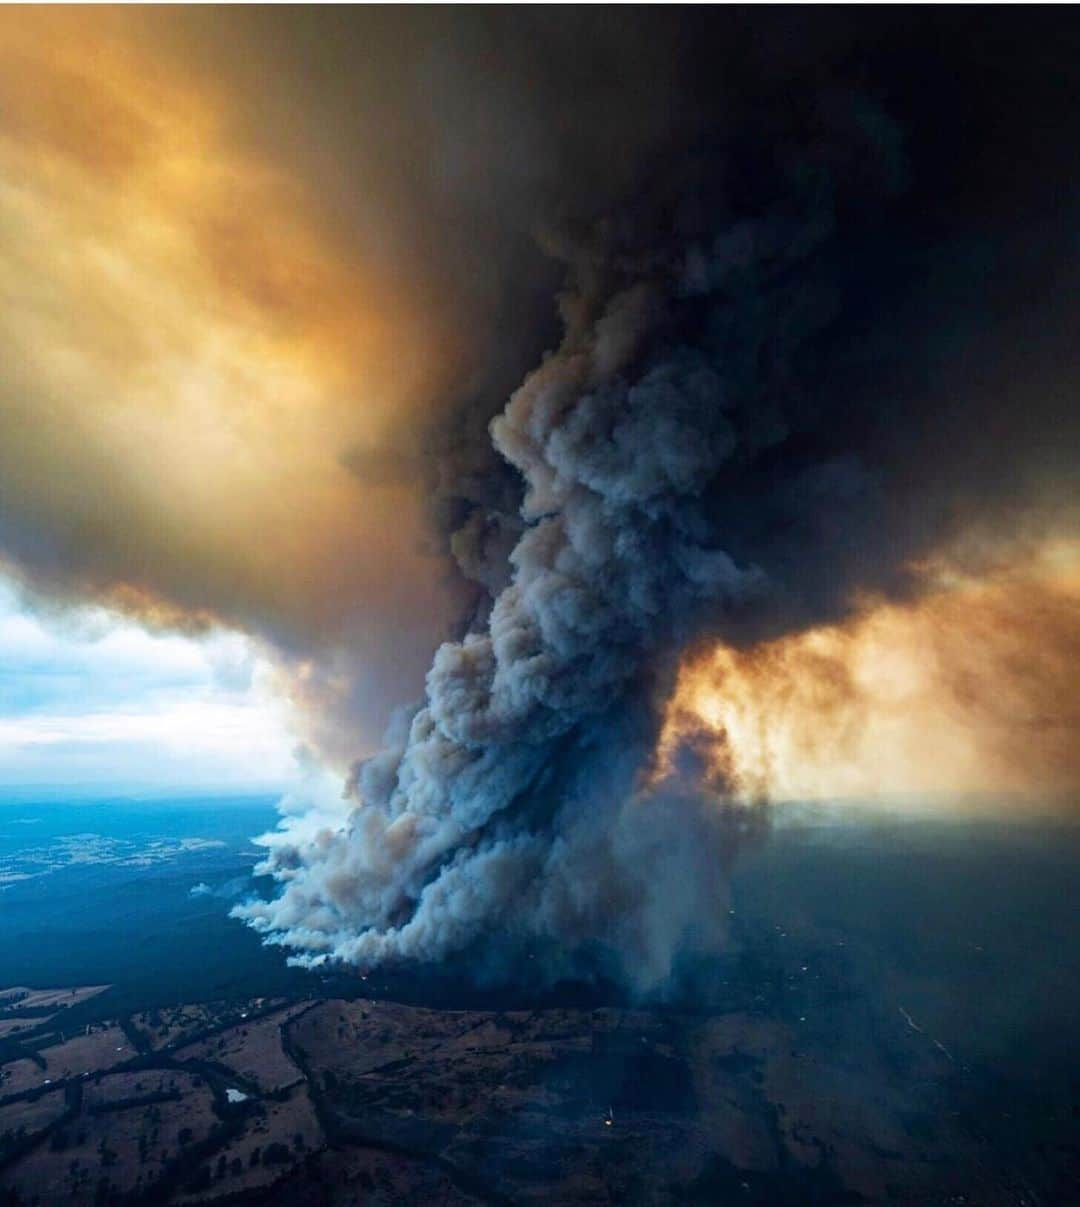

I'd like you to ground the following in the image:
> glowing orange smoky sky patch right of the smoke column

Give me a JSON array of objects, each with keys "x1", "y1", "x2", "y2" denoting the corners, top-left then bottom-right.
[{"x1": 654, "y1": 544, "x2": 1080, "y2": 801}]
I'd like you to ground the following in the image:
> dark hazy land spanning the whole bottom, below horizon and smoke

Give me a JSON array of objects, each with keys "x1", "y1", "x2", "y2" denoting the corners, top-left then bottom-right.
[{"x1": 0, "y1": 800, "x2": 1080, "y2": 1205}]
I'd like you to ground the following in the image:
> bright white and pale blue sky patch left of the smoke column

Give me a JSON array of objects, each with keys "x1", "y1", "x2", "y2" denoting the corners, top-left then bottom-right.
[{"x1": 0, "y1": 578, "x2": 297, "y2": 793}]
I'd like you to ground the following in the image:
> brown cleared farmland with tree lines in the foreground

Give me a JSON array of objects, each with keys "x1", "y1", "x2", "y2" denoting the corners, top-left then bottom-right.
[{"x1": 0, "y1": 970, "x2": 1061, "y2": 1207}]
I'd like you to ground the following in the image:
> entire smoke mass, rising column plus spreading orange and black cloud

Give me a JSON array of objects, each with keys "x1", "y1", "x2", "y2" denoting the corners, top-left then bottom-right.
[{"x1": 0, "y1": 10, "x2": 1080, "y2": 986}]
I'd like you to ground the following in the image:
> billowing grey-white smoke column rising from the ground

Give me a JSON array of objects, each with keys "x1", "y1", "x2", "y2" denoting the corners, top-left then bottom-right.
[{"x1": 237, "y1": 266, "x2": 781, "y2": 984}]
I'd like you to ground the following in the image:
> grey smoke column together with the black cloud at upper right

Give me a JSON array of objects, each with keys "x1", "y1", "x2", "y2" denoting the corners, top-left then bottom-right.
[{"x1": 239, "y1": 11, "x2": 1076, "y2": 986}]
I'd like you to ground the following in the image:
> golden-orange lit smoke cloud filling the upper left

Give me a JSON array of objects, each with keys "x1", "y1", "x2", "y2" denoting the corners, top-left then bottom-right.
[{"x1": 0, "y1": 8, "x2": 463, "y2": 757}]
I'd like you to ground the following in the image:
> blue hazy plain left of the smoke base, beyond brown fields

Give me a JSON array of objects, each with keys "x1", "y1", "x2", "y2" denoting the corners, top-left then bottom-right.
[{"x1": 0, "y1": 797, "x2": 308, "y2": 1004}]
